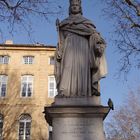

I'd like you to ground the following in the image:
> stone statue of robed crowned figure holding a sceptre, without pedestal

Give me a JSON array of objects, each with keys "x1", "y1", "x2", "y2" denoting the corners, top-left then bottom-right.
[{"x1": 55, "y1": 0, "x2": 107, "y2": 97}]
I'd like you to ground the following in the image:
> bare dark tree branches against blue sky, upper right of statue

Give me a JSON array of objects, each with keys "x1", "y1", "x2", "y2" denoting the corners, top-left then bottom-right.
[{"x1": 101, "y1": 0, "x2": 140, "y2": 74}]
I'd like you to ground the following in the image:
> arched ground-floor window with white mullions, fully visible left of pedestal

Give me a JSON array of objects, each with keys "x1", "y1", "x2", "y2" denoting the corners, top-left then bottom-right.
[{"x1": 19, "y1": 114, "x2": 31, "y2": 140}]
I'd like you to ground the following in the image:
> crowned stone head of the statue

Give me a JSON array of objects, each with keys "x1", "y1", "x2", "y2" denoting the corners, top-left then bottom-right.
[{"x1": 69, "y1": 0, "x2": 82, "y2": 15}]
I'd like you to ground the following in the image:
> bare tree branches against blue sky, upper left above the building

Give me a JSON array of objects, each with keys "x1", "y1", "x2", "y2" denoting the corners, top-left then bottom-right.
[{"x1": 0, "y1": 0, "x2": 61, "y2": 37}]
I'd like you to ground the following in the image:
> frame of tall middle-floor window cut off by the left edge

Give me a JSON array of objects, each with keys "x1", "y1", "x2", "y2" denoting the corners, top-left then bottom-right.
[{"x1": 0, "y1": 74, "x2": 8, "y2": 98}]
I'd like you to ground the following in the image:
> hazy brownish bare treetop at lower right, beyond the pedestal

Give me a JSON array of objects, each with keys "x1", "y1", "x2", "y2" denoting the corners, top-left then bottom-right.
[{"x1": 106, "y1": 89, "x2": 140, "y2": 140}]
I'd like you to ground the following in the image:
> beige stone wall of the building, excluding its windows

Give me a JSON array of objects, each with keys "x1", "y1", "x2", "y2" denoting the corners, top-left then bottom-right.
[{"x1": 0, "y1": 44, "x2": 55, "y2": 140}]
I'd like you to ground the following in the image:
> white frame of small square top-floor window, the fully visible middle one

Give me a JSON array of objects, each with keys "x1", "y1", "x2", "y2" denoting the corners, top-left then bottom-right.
[{"x1": 22, "y1": 55, "x2": 35, "y2": 65}]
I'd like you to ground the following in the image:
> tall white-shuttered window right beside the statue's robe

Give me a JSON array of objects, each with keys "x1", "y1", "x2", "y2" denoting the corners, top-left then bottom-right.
[{"x1": 48, "y1": 76, "x2": 57, "y2": 98}]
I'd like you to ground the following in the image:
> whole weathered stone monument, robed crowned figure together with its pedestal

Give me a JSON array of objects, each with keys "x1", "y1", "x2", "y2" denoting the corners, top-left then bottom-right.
[{"x1": 44, "y1": 0, "x2": 110, "y2": 140}]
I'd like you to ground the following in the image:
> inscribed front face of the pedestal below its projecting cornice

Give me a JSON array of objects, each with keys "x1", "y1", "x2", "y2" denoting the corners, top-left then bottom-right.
[{"x1": 54, "y1": 118, "x2": 103, "y2": 140}]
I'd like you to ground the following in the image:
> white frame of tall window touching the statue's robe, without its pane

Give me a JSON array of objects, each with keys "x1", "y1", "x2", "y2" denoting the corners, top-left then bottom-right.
[{"x1": 48, "y1": 75, "x2": 58, "y2": 98}]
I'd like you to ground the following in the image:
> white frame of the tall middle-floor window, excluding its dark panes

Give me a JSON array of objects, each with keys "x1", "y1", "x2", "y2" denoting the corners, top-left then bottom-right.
[{"x1": 20, "y1": 74, "x2": 34, "y2": 98}]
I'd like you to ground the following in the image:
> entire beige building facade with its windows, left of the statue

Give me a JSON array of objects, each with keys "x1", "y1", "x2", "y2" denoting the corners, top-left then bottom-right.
[{"x1": 0, "y1": 43, "x2": 57, "y2": 140}]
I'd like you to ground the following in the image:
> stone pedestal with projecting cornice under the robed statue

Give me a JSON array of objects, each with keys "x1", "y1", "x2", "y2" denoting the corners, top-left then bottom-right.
[{"x1": 44, "y1": 98, "x2": 110, "y2": 140}]
